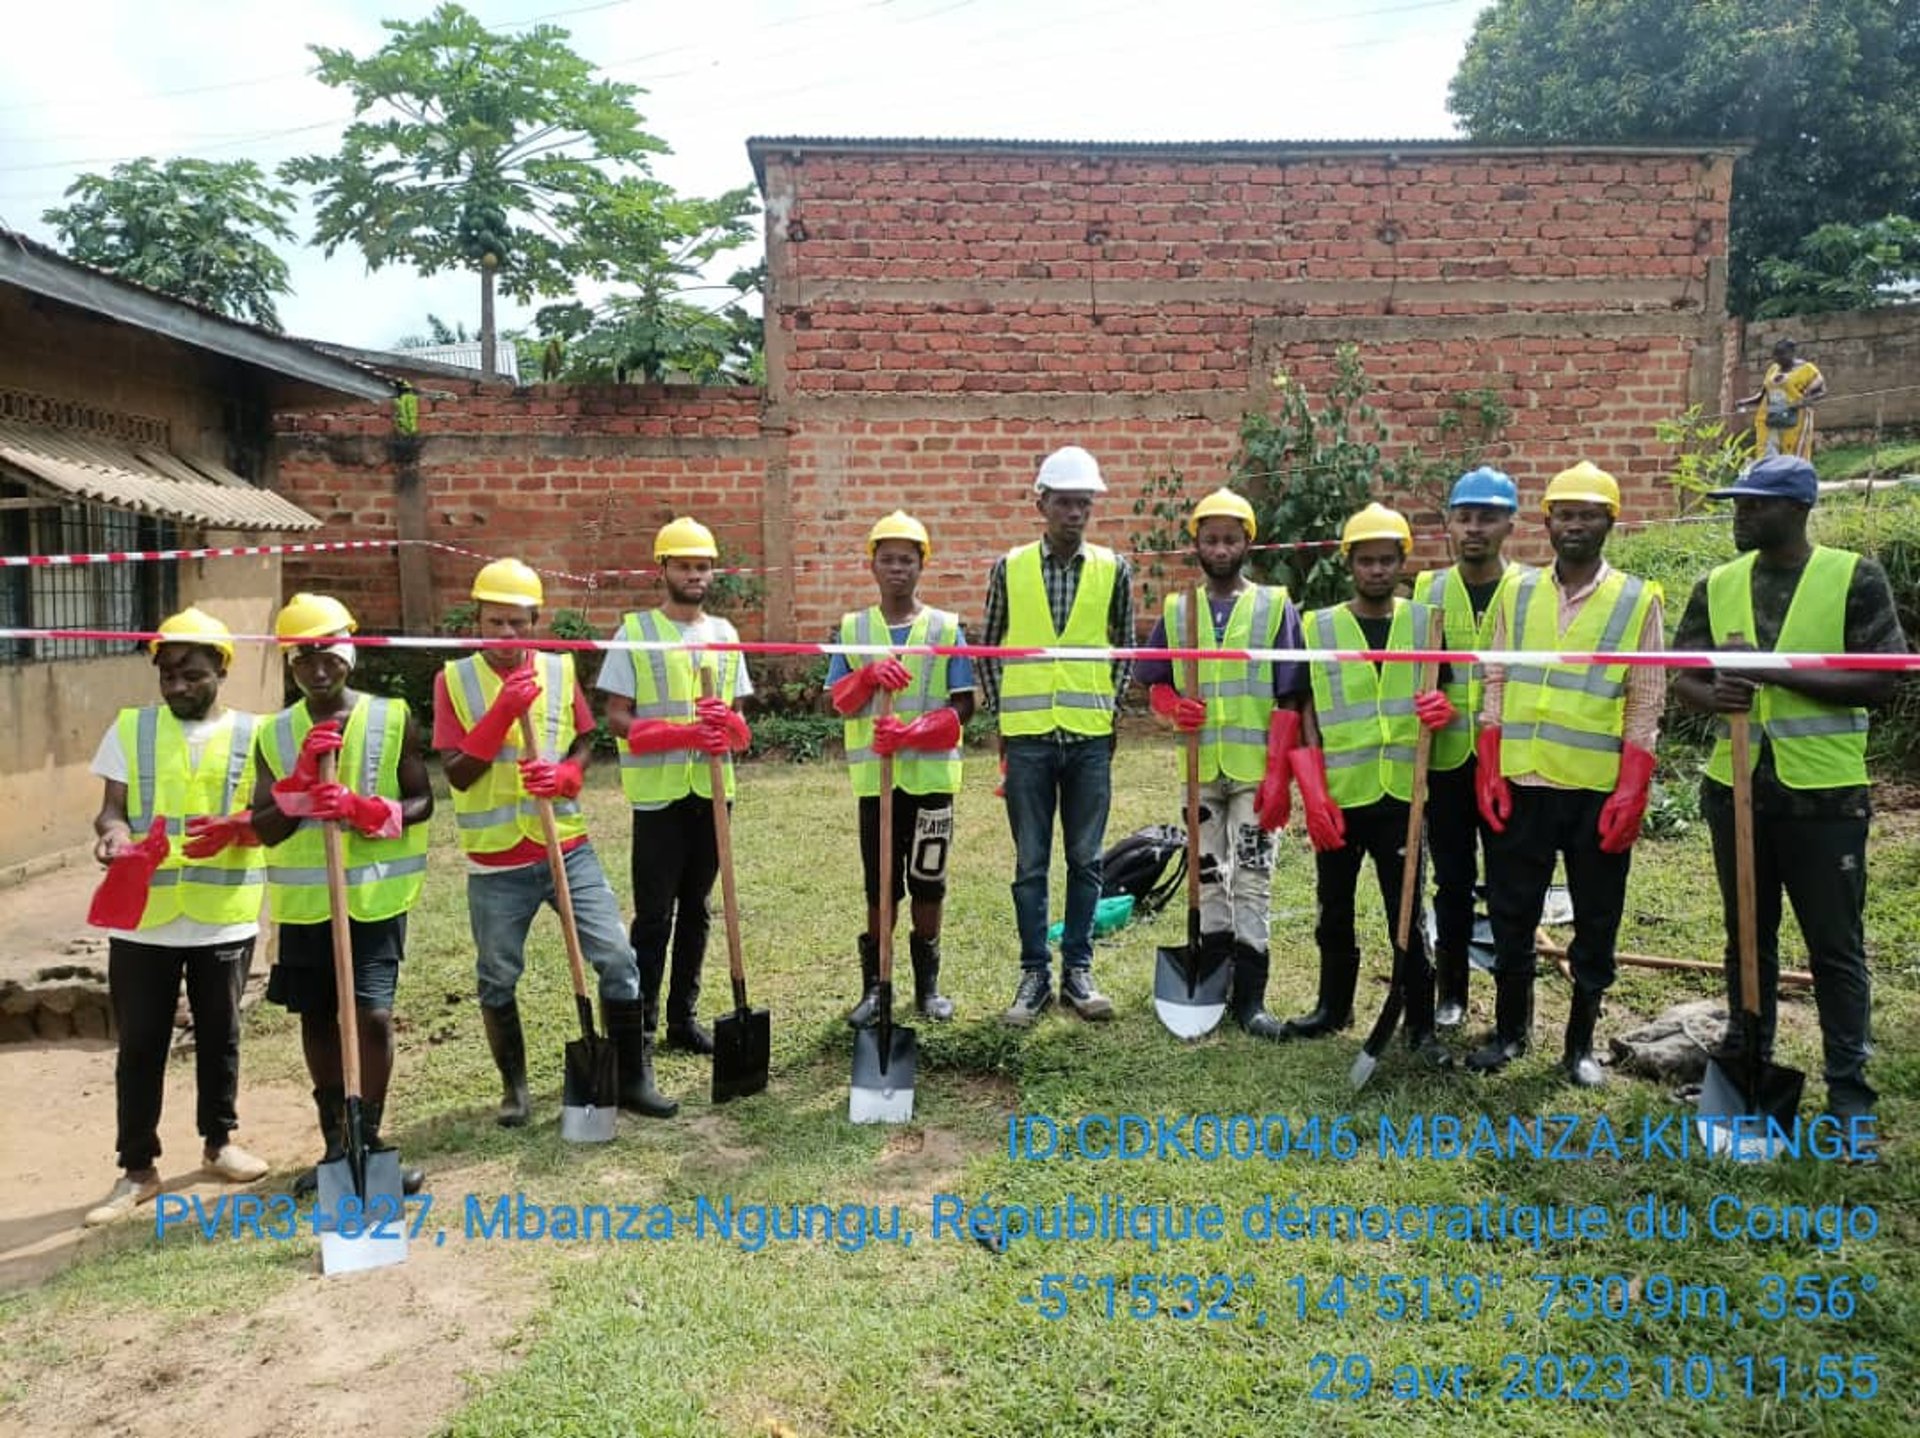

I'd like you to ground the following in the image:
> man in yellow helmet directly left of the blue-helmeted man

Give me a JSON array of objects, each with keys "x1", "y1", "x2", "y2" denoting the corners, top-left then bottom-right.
[{"x1": 1286, "y1": 503, "x2": 1453, "y2": 1069}]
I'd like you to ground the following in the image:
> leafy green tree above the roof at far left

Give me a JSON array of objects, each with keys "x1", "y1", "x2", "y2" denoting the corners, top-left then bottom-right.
[{"x1": 40, "y1": 157, "x2": 296, "y2": 330}]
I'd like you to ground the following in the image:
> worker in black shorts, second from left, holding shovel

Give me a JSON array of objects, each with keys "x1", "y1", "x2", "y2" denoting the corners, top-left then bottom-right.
[{"x1": 253, "y1": 593, "x2": 434, "y2": 1192}]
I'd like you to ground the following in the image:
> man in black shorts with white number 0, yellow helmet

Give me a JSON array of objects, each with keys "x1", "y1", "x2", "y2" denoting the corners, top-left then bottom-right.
[{"x1": 828, "y1": 509, "x2": 973, "y2": 1029}]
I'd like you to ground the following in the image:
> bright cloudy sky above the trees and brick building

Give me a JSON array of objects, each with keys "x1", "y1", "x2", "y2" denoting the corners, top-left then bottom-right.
[{"x1": 0, "y1": 0, "x2": 1486, "y2": 346}]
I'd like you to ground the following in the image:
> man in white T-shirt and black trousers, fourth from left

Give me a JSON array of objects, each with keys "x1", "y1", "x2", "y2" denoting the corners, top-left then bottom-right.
[{"x1": 597, "y1": 518, "x2": 753, "y2": 1054}]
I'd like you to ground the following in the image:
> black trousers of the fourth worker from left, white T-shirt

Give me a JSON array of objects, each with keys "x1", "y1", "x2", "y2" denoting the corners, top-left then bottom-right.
[{"x1": 628, "y1": 795, "x2": 720, "y2": 1031}]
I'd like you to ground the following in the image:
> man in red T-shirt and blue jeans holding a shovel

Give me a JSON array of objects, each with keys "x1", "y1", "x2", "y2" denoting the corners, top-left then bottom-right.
[{"x1": 434, "y1": 559, "x2": 680, "y2": 1129}]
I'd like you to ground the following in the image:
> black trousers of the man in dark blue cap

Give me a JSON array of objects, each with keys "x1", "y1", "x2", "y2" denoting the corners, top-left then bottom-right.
[{"x1": 1699, "y1": 783, "x2": 1880, "y2": 1114}]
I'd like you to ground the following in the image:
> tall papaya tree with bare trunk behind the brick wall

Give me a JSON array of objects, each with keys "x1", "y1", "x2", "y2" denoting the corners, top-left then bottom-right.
[{"x1": 280, "y1": 4, "x2": 751, "y2": 374}]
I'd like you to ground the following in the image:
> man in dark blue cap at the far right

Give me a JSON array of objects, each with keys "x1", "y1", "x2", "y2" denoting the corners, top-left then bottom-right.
[{"x1": 1674, "y1": 455, "x2": 1907, "y2": 1119}]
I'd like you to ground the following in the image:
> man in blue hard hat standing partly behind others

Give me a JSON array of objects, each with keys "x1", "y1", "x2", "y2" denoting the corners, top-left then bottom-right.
[{"x1": 1413, "y1": 467, "x2": 1523, "y2": 1029}]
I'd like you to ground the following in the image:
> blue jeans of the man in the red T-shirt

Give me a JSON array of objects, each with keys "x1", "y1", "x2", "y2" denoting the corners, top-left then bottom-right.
[{"x1": 467, "y1": 843, "x2": 639, "y2": 1008}]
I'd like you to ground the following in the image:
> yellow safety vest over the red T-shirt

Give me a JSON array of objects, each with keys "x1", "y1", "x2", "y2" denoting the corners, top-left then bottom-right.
[{"x1": 445, "y1": 655, "x2": 588, "y2": 854}]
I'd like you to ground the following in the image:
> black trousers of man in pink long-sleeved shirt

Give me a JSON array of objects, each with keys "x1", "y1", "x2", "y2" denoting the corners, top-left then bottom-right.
[{"x1": 1486, "y1": 783, "x2": 1634, "y2": 993}]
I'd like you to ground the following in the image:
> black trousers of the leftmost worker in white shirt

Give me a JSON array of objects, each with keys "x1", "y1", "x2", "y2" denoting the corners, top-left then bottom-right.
[{"x1": 108, "y1": 939, "x2": 255, "y2": 1169}]
